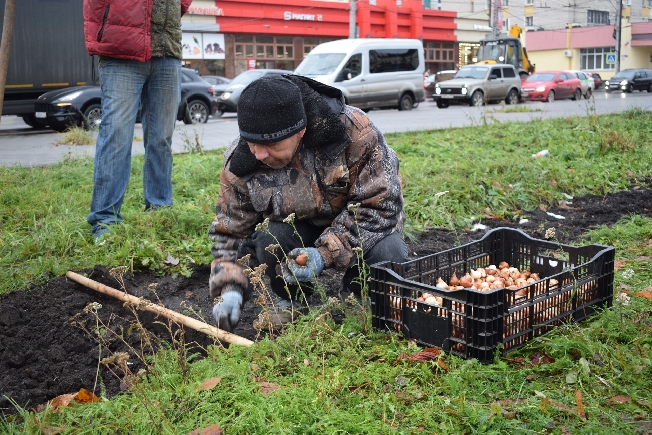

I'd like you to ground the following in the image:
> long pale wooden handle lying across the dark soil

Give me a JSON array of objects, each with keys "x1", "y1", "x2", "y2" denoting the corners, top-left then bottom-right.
[{"x1": 66, "y1": 271, "x2": 254, "y2": 346}]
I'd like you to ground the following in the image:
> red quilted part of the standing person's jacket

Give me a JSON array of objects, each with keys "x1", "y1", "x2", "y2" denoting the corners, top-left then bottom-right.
[{"x1": 84, "y1": 0, "x2": 192, "y2": 62}]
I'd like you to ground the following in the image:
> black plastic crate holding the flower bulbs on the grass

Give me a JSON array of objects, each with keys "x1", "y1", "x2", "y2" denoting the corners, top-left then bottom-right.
[{"x1": 370, "y1": 228, "x2": 615, "y2": 364}]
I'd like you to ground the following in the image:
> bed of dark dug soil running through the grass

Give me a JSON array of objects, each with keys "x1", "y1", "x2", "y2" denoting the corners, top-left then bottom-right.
[{"x1": 0, "y1": 180, "x2": 652, "y2": 414}]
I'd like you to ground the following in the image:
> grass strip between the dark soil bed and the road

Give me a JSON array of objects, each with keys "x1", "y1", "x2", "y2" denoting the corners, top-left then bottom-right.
[{"x1": 0, "y1": 109, "x2": 652, "y2": 294}]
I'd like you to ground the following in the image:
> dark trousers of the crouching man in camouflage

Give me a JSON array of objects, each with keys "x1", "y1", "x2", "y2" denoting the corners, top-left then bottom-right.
[{"x1": 238, "y1": 221, "x2": 409, "y2": 301}]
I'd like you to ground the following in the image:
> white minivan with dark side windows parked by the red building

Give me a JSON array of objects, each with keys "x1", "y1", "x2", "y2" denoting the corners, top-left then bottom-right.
[{"x1": 294, "y1": 38, "x2": 426, "y2": 110}]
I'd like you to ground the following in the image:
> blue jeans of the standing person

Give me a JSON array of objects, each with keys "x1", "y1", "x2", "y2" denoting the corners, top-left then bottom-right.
[{"x1": 86, "y1": 58, "x2": 181, "y2": 237}]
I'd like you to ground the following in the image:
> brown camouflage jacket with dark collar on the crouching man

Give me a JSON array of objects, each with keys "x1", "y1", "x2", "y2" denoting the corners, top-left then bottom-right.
[{"x1": 208, "y1": 75, "x2": 405, "y2": 292}]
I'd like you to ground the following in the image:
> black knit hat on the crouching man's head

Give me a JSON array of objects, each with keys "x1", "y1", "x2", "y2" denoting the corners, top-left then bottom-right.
[{"x1": 238, "y1": 76, "x2": 307, "y2": 144}]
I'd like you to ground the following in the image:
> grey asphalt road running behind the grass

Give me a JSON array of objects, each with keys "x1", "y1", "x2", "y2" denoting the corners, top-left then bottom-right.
[{"x1": 0, "y1": 90, "x2": 652, "y2": 166}]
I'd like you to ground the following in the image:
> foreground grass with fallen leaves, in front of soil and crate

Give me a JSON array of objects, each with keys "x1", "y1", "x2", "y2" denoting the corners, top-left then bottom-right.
[{"x1": 0, "y1": 223, "x2": 652, "y2": 434}]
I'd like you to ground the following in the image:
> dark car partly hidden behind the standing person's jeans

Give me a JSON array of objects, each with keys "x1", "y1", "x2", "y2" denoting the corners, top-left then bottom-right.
[{"x1": 35, "y1": 68, "x2": 217, "y2": 131}]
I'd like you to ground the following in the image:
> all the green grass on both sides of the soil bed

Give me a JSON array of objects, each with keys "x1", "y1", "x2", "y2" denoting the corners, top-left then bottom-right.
[{"x1": 0, "y1": 110, "x2": 652, "y2": 434}]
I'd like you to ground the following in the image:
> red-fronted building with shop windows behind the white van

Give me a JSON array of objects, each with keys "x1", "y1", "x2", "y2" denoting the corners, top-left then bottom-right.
[{"x1": 182, "y1": 0, "x2": 459, "y2": 77}]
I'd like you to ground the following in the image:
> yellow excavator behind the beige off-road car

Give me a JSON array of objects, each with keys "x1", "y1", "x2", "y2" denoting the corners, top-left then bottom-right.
[{"x1": 473, "y1": 25, "x2": 534, "y2": 79}]
